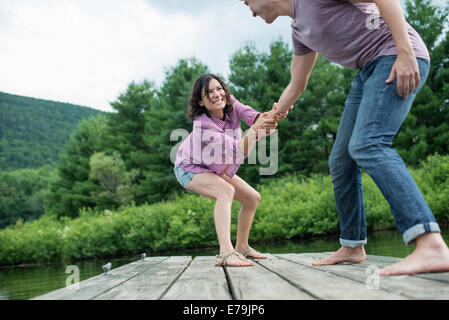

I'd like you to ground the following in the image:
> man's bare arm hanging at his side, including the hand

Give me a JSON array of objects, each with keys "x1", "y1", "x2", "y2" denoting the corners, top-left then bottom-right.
[{"x1": 354, "y1": 0, "x2": 421, "y2": 98}]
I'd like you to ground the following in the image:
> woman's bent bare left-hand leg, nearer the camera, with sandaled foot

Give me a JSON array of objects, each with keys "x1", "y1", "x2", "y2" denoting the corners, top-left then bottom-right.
[{"x1": 187, "y1": 173, "x2": 253, "y2": 266}]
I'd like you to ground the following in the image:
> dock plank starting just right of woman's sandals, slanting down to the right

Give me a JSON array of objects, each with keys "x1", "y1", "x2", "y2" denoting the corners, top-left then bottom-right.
[{"x1": 258, "y1": 255, "x2": 404, "y2": 300}]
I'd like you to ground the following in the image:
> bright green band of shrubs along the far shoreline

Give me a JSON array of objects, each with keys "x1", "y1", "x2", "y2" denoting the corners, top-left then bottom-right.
[{"x1": 0, "y1": 155, "x2": 449, "y2": 266}]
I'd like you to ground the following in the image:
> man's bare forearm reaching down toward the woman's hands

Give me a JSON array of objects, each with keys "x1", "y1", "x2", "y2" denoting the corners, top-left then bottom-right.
[{"x1": 275, "y1": 52, "x2": 318, "y2": 113}]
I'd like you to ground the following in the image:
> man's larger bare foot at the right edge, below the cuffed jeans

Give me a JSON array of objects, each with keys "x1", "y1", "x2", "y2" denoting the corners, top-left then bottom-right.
[{"x1": 378, "y1": 233, "x2": 449, "y2": 276}]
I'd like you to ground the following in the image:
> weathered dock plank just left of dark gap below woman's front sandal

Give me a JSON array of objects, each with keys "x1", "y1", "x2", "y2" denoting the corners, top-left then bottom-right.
[{"x1": 162, "y1": 256, "x2": 232, "y2": 300}]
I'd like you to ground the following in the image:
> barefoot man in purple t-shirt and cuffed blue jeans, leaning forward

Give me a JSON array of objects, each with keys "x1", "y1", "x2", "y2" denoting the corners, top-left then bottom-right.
[{"x1": 242, "y1": 0, "x2": 449, "y2": 275}]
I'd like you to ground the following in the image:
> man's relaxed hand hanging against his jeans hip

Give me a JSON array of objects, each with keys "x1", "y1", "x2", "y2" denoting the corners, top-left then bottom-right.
[{"x1": 385, "y1": 54, "x2": 421, "y2": 99}]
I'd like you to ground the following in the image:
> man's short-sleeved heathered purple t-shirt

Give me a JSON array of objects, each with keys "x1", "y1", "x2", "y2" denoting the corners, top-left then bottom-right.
[{"x1": 292, "y1": 0, "x2": 430, "y2": 69}]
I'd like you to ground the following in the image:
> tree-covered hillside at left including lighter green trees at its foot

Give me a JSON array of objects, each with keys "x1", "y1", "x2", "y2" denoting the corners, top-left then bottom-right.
[{"x1": 0, "y1": 92, "x2": 102, "y2": 228}]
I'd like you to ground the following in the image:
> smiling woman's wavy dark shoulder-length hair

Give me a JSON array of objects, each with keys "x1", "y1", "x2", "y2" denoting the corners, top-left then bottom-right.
[{"x1": 187, "y1": 73, "x2": 232, "y2": 120}]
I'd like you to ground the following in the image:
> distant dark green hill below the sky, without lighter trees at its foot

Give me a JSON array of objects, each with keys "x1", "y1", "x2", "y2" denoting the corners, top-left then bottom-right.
[{"x1": 0, "y1": 92, "x2": 102, "y2": 171}]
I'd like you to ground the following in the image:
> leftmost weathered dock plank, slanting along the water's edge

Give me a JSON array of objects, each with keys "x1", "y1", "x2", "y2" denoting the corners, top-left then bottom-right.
[{"x1": 33, "y1": 257, "x2": 168, "y2": 300}]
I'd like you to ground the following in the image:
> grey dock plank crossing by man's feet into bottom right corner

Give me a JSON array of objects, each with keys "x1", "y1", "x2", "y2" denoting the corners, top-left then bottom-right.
[{"x1": 278, "y1": 254, "x2": 449, "y2": 299}]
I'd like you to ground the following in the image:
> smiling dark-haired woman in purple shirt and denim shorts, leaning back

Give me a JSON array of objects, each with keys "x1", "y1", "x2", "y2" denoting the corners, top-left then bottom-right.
[{"x1": 174, "y1": 74, "x2": 286, "y2": 267}]
